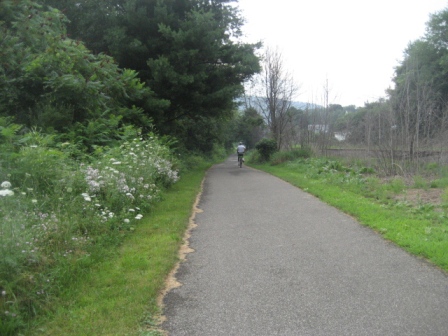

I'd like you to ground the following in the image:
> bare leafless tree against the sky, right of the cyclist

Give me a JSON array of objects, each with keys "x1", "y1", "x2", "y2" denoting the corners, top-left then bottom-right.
[{"x1": 257, "y1": 48, "x2": 298, "y2": 149}]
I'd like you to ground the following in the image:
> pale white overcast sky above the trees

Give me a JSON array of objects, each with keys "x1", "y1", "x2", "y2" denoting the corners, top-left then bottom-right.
[{"x1": 239, "y1": 0, "x2": 448, "y2": 106}]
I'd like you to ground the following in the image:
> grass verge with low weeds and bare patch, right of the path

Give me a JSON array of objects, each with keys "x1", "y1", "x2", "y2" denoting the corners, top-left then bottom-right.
[{"x1": 248, "y1": 151, "x2": 448, "y2": 271}]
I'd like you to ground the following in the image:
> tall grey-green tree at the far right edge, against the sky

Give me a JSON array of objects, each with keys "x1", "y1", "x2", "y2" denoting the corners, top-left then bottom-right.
[{"x1": 389, "y1": 9, "x2": 448, "y2": 165}]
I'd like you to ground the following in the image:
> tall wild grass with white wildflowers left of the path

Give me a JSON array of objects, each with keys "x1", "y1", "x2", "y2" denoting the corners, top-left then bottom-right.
[{"x1": 0, "y1": 136, "x2": 178, "y2": 336}]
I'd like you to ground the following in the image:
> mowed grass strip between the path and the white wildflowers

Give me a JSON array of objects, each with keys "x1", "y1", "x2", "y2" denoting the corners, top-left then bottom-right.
[{"x1": 28, "y1": 166, "x2": 208, "y2": 336}]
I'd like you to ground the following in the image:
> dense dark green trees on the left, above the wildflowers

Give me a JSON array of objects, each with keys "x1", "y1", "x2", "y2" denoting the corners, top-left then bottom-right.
[{"x1": 0, "y1": 0, "x2": 260, "y2": 152}]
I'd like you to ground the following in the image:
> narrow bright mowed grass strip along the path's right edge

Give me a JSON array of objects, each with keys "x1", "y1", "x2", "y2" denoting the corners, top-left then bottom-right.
[{"x1": 251, "y1": 164, "x2": 448, "y2": 271}]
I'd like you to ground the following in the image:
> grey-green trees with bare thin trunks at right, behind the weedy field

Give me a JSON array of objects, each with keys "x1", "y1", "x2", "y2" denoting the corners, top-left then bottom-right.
[{"x1": 300, "y1": 8, "x2": 448, "y2": 174}]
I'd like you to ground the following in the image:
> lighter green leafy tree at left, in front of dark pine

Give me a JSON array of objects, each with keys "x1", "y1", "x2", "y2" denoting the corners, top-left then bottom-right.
[{"x1": 0, "y1": 0, "x2": 152, "y2": 150}]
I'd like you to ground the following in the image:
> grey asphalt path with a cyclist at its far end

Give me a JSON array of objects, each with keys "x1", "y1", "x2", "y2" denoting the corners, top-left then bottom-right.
[{"x1": 162, "y1": 156, "x2": 448, "y2": 336}]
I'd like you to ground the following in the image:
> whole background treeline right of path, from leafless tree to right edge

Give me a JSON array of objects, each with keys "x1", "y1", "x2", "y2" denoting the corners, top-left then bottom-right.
[{"x1": 247, "y1": 4, "x2": 448, "y2": 174}]
